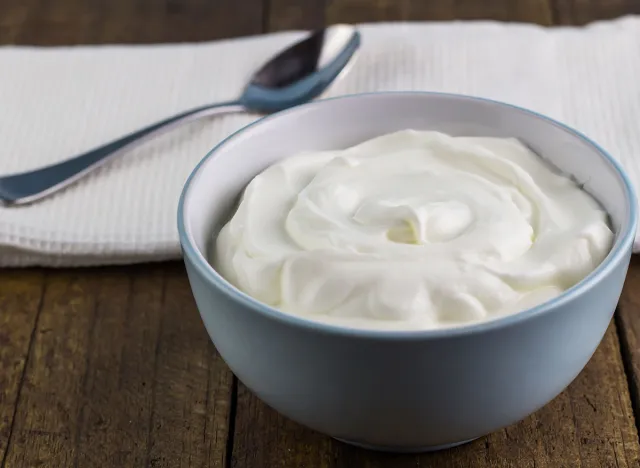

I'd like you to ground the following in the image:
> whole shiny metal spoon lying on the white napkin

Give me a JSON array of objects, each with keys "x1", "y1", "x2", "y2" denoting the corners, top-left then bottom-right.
[{"x1": 0, "y1": 25, "x2": 360, "y2": 206}]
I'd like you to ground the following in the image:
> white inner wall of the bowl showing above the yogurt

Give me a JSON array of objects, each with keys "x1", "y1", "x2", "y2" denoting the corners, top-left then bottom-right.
[{"x1": 180, "y1": 93, "x2": 635, "y2": 286}]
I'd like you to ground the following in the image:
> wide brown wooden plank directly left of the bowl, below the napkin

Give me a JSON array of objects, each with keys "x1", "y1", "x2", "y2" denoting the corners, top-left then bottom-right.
[{"x1": 2, "y1": 264, "x2": 232, "y2": 468}]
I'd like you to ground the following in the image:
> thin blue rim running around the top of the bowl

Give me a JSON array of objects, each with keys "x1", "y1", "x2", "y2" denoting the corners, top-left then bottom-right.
[{"x1": 178, "y1": 91, "x2": 638, "y2": 339}]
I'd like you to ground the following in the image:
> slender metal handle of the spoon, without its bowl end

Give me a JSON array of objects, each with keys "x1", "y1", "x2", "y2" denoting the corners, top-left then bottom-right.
[{"x1": 0, "y1": 102, "x2": 244, "y2": 206}]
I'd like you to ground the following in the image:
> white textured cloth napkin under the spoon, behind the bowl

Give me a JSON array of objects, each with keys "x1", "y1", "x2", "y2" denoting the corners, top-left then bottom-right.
[{"x1": 0, "y1": 17, "x2": 640, "y2": 266}]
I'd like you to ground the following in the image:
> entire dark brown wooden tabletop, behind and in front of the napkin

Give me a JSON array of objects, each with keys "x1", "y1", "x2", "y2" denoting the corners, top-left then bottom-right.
[{"x1": 0, "y1": 0, "x2": 640, "y2": 468}]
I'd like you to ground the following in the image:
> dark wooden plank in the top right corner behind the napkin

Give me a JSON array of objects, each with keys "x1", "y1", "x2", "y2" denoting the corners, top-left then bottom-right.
[{"x1": 552, "y1": 0, "x2": 640, "y2": 25}]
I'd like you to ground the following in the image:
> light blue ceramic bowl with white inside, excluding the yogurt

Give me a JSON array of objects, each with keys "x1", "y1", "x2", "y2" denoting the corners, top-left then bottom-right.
[{"x1": 178, "y1": 93, "x2": 637, "y2": 452}]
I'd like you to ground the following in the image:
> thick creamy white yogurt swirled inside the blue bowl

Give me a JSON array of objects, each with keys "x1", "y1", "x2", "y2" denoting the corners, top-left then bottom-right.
[{"x1": 213, "y1": 130, "x2": 613, "y2": 330}]
